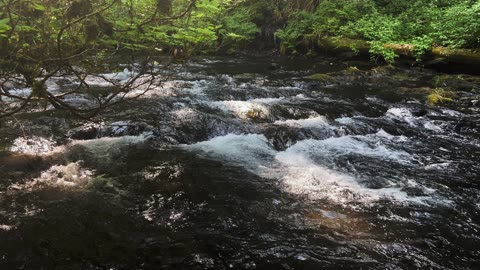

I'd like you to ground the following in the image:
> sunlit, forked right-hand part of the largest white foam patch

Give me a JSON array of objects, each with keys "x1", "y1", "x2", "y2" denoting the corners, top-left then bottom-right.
[{"x1": 269, "y1": 135, "x2": 424, "y2": 203}]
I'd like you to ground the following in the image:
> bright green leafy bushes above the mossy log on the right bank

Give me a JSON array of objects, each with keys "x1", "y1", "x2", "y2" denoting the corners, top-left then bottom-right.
[{"x1": 276, "y1": 0, "x2": 480, "y2": 62}]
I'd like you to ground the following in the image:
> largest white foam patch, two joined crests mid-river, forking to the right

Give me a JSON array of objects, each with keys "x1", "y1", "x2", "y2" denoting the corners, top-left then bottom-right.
[{"x1": 184, "y1": 134, "x2": 429, "y2": 204}]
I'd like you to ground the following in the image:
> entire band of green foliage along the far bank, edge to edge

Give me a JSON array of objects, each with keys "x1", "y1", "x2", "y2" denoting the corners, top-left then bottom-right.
[{"x1": 0, "y1": 0, "x2": 480, "y2": 62}]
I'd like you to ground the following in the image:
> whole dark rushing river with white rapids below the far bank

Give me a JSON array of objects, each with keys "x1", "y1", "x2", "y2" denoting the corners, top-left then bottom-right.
[{"x1": 0, "y1": 56, "x2": 480, "y2": 269}]
